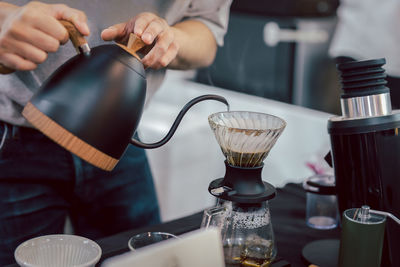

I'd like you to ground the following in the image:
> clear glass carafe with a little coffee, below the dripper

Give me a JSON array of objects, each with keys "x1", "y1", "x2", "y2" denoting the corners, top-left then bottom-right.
[{"x1": 202, "y1": 201, "x2": 277, "y2": 267}]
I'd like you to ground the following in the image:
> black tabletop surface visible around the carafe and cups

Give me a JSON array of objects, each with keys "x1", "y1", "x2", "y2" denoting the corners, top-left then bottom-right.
[{"x1": 7, "y1": 184, "x2": 340, "y2": 267}]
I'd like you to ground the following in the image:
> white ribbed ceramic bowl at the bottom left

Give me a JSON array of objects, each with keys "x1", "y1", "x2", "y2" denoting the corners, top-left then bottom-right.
[{"x1": 14, "y1": 235, "x2": 101, "y2": 267}]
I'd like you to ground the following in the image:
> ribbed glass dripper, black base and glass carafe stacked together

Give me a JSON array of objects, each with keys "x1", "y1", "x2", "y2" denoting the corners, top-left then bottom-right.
[{"x1": 202, "y1": 111, "x2": 286, "y2": 267}]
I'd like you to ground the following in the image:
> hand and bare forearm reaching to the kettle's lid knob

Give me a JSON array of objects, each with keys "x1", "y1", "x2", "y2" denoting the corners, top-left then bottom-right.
[{"x1": 101, "y1": 12, "x2": 217, "y2": 69}]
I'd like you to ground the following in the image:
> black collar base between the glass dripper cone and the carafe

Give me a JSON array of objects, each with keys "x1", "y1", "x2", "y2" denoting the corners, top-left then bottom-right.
[{"x1": 208, "y1": 161, "x2": 276, "y2": 204}]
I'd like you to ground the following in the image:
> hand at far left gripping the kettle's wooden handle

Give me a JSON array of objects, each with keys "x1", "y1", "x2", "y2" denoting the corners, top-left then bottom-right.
[{"x1": 0, "y1": 2, "x2": 89, "y2": 70}]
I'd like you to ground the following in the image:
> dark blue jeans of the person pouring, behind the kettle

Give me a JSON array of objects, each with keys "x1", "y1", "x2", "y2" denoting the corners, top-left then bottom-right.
[{"x1": 0, "y1": 122, "x2": 160, "y2": 266}]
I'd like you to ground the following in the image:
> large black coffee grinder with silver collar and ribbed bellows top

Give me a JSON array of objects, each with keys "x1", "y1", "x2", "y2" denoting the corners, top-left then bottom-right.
[{"x1": 328, "y1": 59, "x2": 400, "y2": 266}]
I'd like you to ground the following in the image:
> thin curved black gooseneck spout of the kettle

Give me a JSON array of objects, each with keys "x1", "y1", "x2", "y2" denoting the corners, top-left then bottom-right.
[{"x1": 131, "y1": 95, "x2": 229, "y2": 149}]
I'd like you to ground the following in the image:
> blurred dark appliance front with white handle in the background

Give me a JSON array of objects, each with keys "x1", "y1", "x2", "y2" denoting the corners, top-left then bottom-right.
[{"x1": 194, "y1": 0, "x2": 340, "y2": 114}]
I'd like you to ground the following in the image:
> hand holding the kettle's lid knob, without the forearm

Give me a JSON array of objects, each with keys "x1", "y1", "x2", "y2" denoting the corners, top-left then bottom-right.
[{"x1": 101, "y1": 12, "x2": 179, "y2": 69}]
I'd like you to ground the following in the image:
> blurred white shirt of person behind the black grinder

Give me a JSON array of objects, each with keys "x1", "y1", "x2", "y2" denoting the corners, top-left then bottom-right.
[{"x1": 329, "y1": 0, "x2": 400, "y2": 77}]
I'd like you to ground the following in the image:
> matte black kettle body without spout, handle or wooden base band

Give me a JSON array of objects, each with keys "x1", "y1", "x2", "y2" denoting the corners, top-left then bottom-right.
[{"x1": 30, "y1": 44, "x2": 146, "y2": 158}]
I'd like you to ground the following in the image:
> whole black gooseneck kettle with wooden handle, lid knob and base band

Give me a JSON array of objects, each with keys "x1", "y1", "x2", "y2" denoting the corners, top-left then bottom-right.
[{"x1": 0, "y1": 21, "x2": 228, "y2": 171}]
